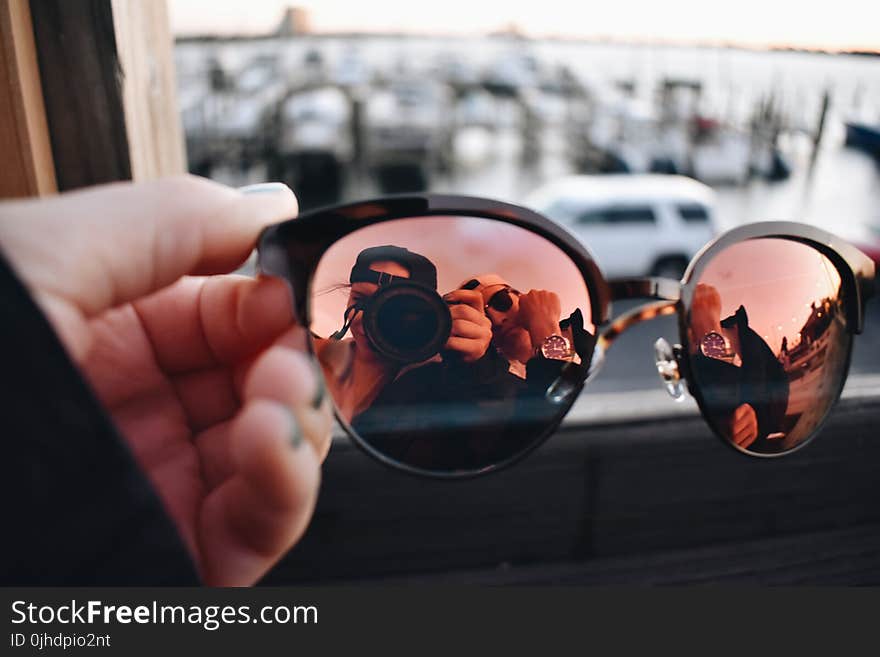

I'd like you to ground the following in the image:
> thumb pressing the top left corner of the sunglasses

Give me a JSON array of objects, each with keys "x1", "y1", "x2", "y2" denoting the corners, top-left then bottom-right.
[{"x1": 0, "y1": 176, "x2": 297, "y2": 317}]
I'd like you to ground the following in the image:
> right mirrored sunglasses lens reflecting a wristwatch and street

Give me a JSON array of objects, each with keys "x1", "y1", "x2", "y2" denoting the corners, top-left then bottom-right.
[{"x1": 688, "y1": 238, "x2": 852, "y2": 455}]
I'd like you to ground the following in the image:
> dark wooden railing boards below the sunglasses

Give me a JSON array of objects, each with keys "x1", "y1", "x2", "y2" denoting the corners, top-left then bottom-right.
[{"x1": 265, "y1": 397, "x2": 880, "y2": 584}]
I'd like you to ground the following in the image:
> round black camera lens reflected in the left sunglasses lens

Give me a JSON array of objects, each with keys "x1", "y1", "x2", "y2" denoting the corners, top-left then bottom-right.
[{"x1": 361, "y1": 280, "x2": 452, "y2": 364}]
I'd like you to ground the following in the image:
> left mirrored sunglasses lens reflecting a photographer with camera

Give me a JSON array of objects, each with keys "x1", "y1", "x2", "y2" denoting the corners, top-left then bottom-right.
[{"x1": 309, "y1": 217, "x2": 596, "y2": 475}]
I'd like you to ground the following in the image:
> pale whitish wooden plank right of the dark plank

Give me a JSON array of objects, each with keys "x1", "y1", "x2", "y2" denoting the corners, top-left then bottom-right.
[{"x1": 112, "y1": 0, "x2": 186, "y2": 180}]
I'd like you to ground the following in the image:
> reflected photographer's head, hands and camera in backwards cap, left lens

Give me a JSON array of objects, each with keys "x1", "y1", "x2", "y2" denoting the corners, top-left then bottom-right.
[{"x1": 316, "y1": 245, "x2": 492, "y2": 420}]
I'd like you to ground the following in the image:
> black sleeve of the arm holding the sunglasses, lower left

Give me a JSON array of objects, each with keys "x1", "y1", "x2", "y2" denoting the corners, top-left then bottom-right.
[{"x1": 0, "y1": 253, "x2": 199, "y2": 586}]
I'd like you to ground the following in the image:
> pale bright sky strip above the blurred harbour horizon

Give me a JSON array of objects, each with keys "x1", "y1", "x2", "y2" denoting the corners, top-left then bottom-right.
[{"x1": 168, "y1": 0, "x2": 880, "y2": 51}]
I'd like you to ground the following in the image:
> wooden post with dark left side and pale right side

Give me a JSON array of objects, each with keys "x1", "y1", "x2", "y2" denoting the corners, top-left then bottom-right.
[{"x1": 30, "y1": 0, "x2": 185, "y2": 190}]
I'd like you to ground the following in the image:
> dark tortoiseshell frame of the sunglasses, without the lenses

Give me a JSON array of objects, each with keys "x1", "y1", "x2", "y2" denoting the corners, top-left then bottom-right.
[{"x1": 258, "y1": 194, "x2": 874, "y2": 479}]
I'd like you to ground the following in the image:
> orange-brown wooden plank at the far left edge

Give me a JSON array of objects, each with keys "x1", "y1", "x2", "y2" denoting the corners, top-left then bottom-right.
[{"x1": 0, "y1": 0, "x2": 57, "y2": 198}]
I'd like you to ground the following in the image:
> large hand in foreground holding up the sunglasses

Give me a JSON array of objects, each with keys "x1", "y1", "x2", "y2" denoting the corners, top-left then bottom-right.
[{"x1": 0, "y1": 177, "x2": 331, "y2": 585}]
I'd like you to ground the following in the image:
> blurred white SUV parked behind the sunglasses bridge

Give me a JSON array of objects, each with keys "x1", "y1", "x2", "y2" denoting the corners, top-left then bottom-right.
[{"x1": 524, "y1": 174, "x2": 717, "y2": 278}]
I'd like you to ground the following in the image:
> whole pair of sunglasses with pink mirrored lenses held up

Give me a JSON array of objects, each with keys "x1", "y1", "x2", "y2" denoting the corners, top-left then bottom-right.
[{"x1": 258, "y1": 194, "x2": 875, "y2": 478}]
